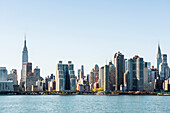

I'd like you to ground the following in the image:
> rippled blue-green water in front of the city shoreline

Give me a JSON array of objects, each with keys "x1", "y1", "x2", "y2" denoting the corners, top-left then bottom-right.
[{"x1": 0, "y1": 95, "x2": 170, "y2": 113}]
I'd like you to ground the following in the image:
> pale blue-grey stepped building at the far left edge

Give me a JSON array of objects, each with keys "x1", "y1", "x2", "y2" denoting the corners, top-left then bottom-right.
[{"x1": 0, "y1": 67, "x2": 13, "y2": 91}]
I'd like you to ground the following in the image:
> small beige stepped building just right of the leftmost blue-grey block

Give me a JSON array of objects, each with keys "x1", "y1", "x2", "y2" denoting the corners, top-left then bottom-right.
[{"x1": 7, "y1": 69, "x2": 18, "y2": 85}]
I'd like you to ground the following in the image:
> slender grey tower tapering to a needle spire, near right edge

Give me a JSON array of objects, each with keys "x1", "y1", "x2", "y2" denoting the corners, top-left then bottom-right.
[{"x1": 155, "y1": 44, "x2": 162, "y2": 70}]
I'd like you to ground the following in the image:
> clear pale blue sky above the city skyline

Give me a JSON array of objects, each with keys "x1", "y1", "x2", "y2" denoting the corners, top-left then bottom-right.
[{"x1": 0, "y1": 0, "x2": 170, "y2": 78}]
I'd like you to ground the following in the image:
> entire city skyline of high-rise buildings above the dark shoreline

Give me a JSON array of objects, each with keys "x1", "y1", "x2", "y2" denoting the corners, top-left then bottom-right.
[{"x1": 0, "y1": 39, "x2": 170, "y2": 92}]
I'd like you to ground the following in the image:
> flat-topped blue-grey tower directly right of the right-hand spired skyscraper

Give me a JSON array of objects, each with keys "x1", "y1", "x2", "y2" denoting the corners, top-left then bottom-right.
[{"x1": 159, "y1": 54, "x2": 170, "y2": 80}]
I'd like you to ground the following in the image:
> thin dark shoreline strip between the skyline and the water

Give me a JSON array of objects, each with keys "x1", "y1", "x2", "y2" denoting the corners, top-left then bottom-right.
[{"x1": 0, "y1": 91, "x2": 170, "y2": 96}]
